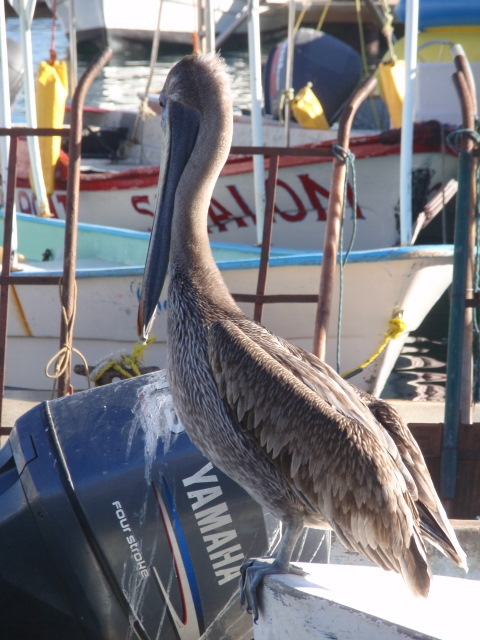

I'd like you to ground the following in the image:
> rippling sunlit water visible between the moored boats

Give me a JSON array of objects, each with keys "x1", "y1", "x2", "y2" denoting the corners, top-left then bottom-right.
[{"x1": 7, "y1": 17, "x2": 449, "y2": 400}]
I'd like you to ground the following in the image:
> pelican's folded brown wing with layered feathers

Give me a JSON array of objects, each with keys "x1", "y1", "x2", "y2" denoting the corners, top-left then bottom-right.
[{"x1": 209, "y1": 320, "x2": 427, "y2": 592}]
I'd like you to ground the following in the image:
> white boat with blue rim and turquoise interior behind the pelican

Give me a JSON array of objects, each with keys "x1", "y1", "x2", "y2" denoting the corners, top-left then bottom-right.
[{"x1": 0, "y1": 214, "x2": 453, "y2": 394}]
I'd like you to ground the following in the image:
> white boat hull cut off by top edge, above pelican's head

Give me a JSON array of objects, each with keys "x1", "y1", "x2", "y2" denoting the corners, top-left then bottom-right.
[{"x1": 40, "y1": 0, "x2": 396, "y2": 54}]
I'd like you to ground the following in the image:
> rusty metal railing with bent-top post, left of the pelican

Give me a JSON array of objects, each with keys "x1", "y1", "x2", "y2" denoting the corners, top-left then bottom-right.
[{"x1": 0, "y1": 49, "x2": 112, "y2": 435}]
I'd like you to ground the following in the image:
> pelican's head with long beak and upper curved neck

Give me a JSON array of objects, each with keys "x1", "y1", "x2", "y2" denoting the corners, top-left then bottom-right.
[{"x1": 137, "y1": 54, "x2": 233, "y2": 340}]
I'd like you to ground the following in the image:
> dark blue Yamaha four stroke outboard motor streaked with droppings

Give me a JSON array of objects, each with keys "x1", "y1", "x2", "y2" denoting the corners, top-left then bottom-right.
[{"x1": 0, "y1": 371, "x2": 328, "y2": 640}]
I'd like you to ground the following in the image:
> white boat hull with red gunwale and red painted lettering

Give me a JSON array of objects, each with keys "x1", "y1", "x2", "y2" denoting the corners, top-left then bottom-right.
[{"x1": 16, "y1": 119, "x2": 457, "y2": 250}]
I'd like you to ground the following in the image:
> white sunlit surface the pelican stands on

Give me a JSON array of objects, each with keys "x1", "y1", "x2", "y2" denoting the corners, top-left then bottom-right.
[{"x1": 254, "y1": 564, "x2": 480, "y2": 640}]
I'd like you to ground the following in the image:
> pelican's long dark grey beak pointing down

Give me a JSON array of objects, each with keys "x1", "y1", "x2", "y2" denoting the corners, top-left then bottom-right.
[{"x1": 137, "y1": 99, "x2": 200, "y2": 340}]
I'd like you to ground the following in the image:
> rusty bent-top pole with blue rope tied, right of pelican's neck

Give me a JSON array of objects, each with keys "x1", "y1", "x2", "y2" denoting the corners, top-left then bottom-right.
[{"x1": 312, "y1": 77, "x2": 377, "y2": 360}]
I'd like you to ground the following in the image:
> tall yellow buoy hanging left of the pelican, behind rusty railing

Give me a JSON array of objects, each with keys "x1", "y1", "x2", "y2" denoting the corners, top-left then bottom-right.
[{"x1": 37, "y1": 60, "x2": 68, "y2": 195}]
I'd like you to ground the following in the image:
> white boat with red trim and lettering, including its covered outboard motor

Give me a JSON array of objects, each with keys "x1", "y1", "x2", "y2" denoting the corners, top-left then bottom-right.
[{"x1": 5, "y1": 3, "x2": 470, "y2": 250}]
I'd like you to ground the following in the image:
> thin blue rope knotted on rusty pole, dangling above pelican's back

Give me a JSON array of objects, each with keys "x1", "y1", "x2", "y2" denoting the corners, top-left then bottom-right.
[{"x1": 332, "y1": 144, "x2": 357, "y2": 371}]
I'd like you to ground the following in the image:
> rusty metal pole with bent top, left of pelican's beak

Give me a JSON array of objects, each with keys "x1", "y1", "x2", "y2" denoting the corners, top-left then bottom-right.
[{"x1": 58, "y1": 48, "x2": 112, "y2": 397}]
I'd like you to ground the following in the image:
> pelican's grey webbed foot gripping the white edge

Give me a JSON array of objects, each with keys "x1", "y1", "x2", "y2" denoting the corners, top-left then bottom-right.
[{"x1": 240, "y1": 558, "x2": 307, "y2": 622}]
